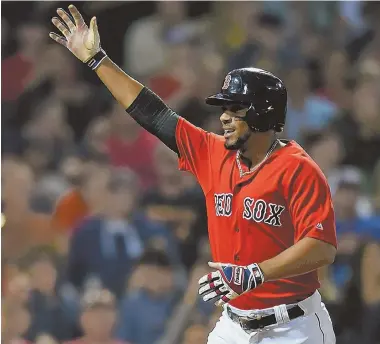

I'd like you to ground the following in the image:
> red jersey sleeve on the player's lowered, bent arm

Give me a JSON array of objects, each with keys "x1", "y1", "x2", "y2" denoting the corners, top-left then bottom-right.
[{"x1": 288, "y1": 160, "x2": 337, "y2": 247}]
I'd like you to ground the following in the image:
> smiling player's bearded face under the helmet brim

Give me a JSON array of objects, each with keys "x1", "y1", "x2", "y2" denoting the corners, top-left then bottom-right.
[{"x1": 220, "y1": 105, "x2": 251, "y2": 150}]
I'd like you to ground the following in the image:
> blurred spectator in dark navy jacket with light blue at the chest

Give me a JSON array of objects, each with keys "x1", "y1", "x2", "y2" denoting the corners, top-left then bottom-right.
[{"x1": 68, "y1": 170, "x2": 144, "y2": 297}]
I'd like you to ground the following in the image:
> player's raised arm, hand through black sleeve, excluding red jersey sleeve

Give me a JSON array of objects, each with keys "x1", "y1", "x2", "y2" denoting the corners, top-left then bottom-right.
[{"x1": 50, "y1": 5, "x2": 179, "y2": 153}]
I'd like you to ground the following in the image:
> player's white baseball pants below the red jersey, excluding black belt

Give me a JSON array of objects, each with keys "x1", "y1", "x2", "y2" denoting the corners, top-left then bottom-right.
[{"x1": 207, "y1": 291, "x2": 336, "y2": 344}]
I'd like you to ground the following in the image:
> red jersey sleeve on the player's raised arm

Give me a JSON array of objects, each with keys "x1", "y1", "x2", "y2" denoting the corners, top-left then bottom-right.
[{"x1": 176, "y1": 118, "x2": 215, "y2": 193}]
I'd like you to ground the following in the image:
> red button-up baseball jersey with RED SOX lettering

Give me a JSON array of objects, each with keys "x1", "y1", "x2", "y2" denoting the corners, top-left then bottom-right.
[{"x1": 176, "y1": 118, "x2": 336, "y2": 310}]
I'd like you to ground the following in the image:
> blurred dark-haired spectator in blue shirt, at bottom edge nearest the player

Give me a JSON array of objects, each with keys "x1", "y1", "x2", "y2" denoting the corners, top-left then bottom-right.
[{"x1": 117, "y1": 250, "x2": 179, "y2": 344}]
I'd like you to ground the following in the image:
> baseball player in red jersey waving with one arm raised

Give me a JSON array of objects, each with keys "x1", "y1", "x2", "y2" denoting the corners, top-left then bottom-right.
[{"x1": 50, "y1": 5, "x2": 336, "y2": 344}]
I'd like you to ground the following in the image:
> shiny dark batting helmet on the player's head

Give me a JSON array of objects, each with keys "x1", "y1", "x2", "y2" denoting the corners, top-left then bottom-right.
[{"x1": 206, "y1": 68, "x2": 287, "y2": 132}]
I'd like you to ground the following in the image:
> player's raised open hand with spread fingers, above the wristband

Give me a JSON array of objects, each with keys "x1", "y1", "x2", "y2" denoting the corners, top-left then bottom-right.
[{"x1": 49, "y1": 5, "x2": 101, "y2": 63}]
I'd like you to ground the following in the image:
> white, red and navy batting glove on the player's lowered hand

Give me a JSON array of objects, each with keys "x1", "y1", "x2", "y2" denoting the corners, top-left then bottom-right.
[{"x1": 198, "y1": 263, "x2": 264, "y2": 306}]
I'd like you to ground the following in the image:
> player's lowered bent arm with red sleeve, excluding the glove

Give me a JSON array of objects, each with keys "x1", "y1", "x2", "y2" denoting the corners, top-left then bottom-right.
[{"x1": 259, "y1": 161, "x2": 337, "y2": 281}]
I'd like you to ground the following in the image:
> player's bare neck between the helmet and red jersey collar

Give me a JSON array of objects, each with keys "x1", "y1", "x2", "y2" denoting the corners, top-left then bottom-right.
[{"x1": 242, "y1": 132, "x2": 276, "y2": 167}]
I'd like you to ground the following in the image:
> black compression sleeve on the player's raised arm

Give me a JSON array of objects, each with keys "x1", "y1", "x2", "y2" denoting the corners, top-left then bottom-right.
[{"x1": 125, "y1": 87, "x2": 179, "y2": 154}]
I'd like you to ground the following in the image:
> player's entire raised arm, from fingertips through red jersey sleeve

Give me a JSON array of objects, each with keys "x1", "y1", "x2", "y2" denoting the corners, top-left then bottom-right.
[{"x1": 50, "y1": 5, "x2": 215, "y2": 188}]
